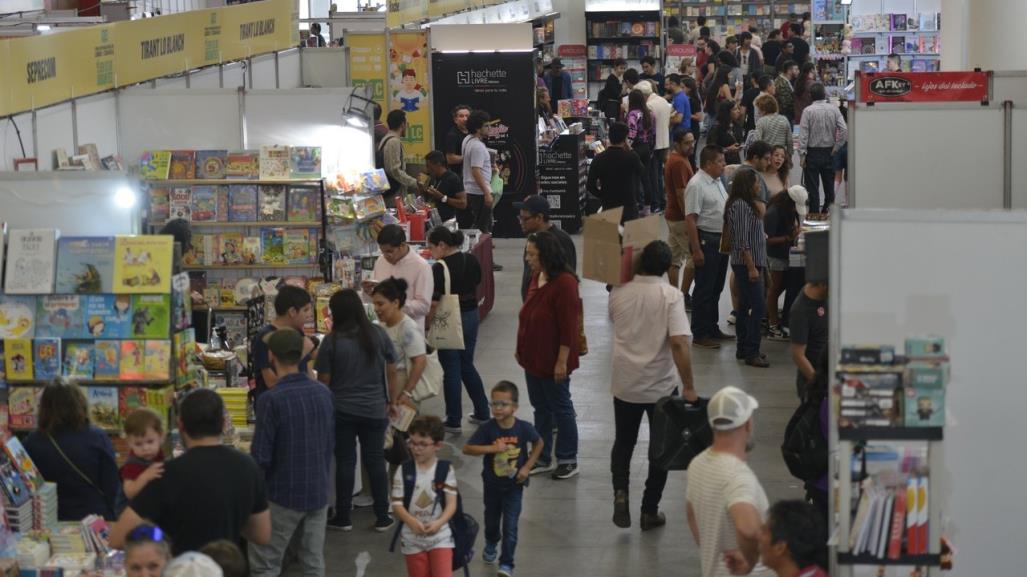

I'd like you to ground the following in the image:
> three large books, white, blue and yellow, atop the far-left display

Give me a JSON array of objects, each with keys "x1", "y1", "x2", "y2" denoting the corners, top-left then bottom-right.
[{"x1": 0, "y1": 229, "x2": 174, "y2": 293}]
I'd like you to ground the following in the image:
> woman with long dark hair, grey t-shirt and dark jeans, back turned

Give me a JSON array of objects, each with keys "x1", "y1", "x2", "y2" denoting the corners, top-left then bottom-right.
[{"x1": 316, "y1": 289, "x2": 407, "y2": 532}]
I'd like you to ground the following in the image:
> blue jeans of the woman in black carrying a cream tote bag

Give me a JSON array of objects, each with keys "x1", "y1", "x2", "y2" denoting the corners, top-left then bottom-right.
[{"x1": 439, "y1": 309, "x2": 492, "y2": 427}]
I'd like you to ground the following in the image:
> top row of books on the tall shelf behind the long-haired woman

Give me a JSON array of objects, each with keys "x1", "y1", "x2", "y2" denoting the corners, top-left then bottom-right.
[{"x1": 139, "y1": 146, "x2": 321, "y2": 181}]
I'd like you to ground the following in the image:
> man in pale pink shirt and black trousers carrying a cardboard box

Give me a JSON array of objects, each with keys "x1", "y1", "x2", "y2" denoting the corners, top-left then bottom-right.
[{"x1": 609, "y1": 240, "x2": 698, "y2": 531}]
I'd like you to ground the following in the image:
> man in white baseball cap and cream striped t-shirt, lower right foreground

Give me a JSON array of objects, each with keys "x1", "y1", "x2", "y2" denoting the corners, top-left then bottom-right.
[{"x1": 685, "y1": 386, "x2": 773, "y2": 577}]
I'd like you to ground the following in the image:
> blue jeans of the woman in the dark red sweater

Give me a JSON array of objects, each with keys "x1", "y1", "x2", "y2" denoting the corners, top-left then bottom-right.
[{"x1": 524, "y1": 373, "x2": 577, "y2": 465}]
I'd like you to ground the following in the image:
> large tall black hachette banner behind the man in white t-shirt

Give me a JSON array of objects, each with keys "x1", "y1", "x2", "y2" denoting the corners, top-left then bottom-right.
[{"x1": 431, "y1": 51, "x2": 537, "y2": 238}]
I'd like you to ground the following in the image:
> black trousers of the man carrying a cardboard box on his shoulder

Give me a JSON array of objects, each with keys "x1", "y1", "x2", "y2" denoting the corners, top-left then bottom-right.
[{"x1": 610, "y1": 398, "x2": 667, "y2": 514}]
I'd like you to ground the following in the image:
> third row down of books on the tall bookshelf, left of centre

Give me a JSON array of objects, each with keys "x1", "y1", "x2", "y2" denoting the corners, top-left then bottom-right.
[{"x1": 182, "y1": 227, "x2": 320, "y2": 267}]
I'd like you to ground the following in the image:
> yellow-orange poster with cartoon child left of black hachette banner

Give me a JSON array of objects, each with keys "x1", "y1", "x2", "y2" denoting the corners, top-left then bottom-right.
[{"x1": 388, "y1": 32, "x2": 431, "y2": 164}]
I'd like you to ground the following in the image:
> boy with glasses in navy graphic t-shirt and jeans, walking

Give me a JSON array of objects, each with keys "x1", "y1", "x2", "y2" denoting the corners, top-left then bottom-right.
[{"x1": 463, "y1": 381, "x2": 542, "y2": 577}]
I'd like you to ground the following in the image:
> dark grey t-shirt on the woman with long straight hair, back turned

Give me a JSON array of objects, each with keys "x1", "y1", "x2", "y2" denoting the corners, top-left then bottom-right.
[{"x1": 314, "y1": 325, "x2": 396, "y2": 419}]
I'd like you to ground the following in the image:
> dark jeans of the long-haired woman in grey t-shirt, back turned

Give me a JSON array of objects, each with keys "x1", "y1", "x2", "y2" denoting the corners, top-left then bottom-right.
[{"x1": 335, "y1": 412, "x2": 388, "y2": 521}]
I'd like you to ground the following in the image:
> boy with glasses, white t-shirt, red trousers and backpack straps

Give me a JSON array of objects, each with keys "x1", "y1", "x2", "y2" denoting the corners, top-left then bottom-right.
[{"x1": 392, "y1": 417, "x2": 457, "y2": 577}]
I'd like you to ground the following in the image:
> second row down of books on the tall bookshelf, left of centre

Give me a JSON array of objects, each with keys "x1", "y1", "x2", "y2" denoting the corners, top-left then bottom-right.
[{"x1": 149, "y1": 185, "x2": 321, "y2": 224}]
